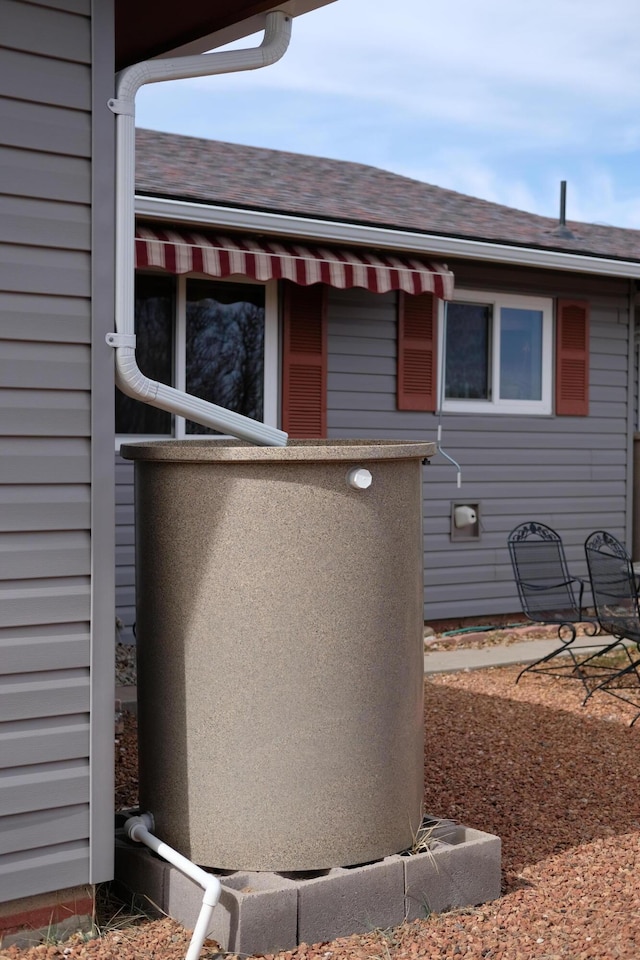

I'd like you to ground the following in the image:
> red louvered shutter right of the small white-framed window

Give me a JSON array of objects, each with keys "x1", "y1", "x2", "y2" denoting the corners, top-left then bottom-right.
[{"x1": 556, "y1": 300, "x2": 589, "y2": 417}]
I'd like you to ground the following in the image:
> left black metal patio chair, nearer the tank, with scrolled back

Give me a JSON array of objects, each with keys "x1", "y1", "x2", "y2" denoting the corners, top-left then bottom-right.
[{"x1": 507, "y1": 520, "x2": 618, "y2": 693}]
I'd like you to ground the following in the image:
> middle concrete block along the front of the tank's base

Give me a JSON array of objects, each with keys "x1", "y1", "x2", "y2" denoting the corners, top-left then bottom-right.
[{"x1": 298, "y1": 855, "x2": 404, "y2": 943}]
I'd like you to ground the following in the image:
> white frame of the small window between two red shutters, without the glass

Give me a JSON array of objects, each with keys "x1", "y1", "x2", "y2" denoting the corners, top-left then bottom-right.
[{"x1": 438, "y1": 289, "x2": 553, "y2": 416}]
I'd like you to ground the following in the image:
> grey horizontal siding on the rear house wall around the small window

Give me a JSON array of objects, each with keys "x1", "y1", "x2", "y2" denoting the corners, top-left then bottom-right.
[{"x1": 328, "y1": 264, "x2": 632, "y2": 620}]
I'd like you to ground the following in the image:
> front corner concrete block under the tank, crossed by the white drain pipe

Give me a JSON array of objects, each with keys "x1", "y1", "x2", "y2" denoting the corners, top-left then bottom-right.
[{"x1": 170, "y1": 867, "x2": 298, "y2": 956}]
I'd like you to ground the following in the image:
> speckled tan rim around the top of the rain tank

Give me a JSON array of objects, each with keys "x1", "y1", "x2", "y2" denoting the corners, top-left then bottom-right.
[{"x1": 120, "y1": 438, "x2": 436, "y2": 463}]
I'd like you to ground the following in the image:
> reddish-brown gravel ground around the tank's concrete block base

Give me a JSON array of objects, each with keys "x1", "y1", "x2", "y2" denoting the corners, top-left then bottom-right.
[{"x1": 5, "y1": 637, "x2": 640, "y2": 960}]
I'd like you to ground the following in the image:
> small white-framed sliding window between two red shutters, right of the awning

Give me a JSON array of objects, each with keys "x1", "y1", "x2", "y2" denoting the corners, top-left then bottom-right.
[{"x1": 441, "y1": 291, "x2": 553, "y2": 414}]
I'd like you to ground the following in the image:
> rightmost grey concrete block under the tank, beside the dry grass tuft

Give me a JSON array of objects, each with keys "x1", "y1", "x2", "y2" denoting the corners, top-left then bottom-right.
[{"x1": 402, "y1": 825, "x2": 501, "y2": 920}]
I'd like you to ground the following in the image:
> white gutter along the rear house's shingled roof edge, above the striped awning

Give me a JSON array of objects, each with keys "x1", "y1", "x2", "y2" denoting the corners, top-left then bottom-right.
[{"x1": 135, "y1": 195, "x2": 640, "y2": 279}]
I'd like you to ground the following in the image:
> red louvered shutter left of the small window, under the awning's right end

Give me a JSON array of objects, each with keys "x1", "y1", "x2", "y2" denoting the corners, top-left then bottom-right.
[{"x1": 397, "y1": 291, "x2": 438, "y2": 412}]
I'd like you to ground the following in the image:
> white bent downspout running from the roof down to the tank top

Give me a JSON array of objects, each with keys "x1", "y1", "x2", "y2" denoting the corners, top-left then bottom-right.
[{"x1": 106, "y1": 11, "x2": 291, "y2": 446}]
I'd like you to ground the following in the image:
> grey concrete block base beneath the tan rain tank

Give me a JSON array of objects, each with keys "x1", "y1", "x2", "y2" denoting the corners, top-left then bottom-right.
[{"x1": 115, "y1": 821, "x2": 501, "y2": 955}]
